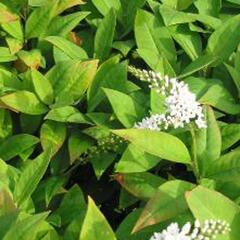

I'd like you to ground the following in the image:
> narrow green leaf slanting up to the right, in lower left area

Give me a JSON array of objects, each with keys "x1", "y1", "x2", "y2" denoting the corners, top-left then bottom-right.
[{"x1": 14, "y1": 150, "x2": 51, "y2": 206}]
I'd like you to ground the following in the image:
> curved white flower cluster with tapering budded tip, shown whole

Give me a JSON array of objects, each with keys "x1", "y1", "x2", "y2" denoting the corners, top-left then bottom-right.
[{"x1": 128, "y1": 66, "x2": 207, "y2": 131}]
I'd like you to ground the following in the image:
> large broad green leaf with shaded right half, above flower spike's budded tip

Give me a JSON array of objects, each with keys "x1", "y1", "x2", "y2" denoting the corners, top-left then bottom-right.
[{"x1": 134, "y1": 10, "x2": 176, "y2": 63}]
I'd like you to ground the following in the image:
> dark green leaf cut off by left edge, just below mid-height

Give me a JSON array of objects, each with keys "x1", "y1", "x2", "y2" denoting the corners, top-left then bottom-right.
[{"x1": 0, "y1": 134, "x2": 39, "y2": 161}]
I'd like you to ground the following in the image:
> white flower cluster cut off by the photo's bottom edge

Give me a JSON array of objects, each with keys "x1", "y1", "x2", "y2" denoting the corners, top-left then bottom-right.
[{"x1": 150, "y1": 220, "x2": 231, "y2": 240}]
